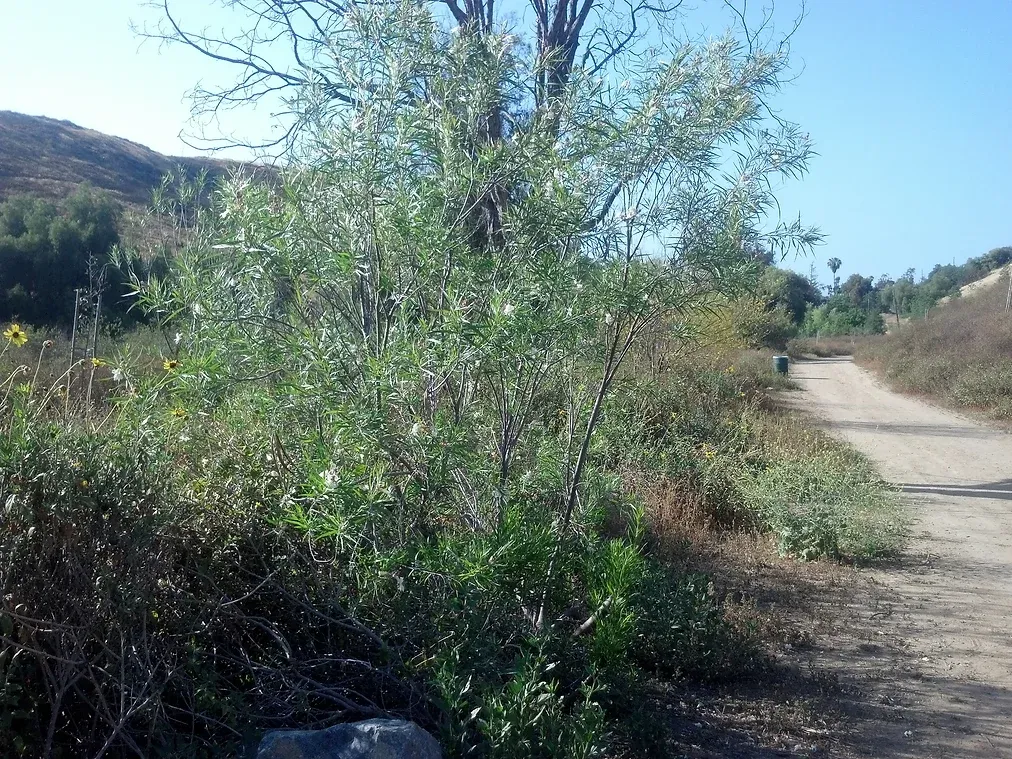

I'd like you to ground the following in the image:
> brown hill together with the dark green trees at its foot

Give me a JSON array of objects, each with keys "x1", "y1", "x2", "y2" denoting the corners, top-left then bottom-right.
[{"x1": 0, "y1": 111, "x2": 269, "y2": 329}]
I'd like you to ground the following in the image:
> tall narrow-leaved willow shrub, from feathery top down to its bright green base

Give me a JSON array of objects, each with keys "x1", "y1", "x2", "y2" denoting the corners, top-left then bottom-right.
[{"x1": 110, "y1": 3, "x2": 816, "y2": 756}]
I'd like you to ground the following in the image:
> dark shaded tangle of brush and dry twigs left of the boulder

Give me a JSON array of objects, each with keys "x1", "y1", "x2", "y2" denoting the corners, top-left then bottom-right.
[{"x1": 0, "y1": 416, "x2": 422, "y2": 756}]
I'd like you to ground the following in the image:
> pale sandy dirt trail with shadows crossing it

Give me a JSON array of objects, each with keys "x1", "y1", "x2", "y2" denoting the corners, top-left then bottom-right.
[{"x1": 790, "y1": 359, "x2": 1012, "y2": 758}]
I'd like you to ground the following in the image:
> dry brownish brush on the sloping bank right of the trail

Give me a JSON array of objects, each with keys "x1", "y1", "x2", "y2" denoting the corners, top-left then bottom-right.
[{"x1": 854, "y1": 274, "x2": 1012, "y2": 419}]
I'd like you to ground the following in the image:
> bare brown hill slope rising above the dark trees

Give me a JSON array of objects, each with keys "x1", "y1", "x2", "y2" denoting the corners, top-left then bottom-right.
[{"x1": 0, "y1": 110, "x2": 241, "y2": 205}]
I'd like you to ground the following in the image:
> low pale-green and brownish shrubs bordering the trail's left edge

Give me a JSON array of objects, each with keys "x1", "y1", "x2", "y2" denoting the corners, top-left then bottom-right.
[{"x1": 601, "y1": 352, "x2": 905, "y2": 559}]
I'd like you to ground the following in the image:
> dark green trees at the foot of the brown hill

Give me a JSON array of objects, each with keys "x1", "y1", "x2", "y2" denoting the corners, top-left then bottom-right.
[{"x1": 0, "y1": 187, "x2": 157, "y2": 328}]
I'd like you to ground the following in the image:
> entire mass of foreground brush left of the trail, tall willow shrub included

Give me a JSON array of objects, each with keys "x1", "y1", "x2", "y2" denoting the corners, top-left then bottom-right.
[{"x1": 0, "y1": 3, "x2": 903, "y2": 758}]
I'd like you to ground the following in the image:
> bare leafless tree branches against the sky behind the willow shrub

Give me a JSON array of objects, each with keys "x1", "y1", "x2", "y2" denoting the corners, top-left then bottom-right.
[{"x1": 139, "y1": 0, "x2": 700, "y2": 152}]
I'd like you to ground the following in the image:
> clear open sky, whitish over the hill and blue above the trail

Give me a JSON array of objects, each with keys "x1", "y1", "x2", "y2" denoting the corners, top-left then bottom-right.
[{"x1": 0, "y1": 0, "x2": 1012, "y2": 281}]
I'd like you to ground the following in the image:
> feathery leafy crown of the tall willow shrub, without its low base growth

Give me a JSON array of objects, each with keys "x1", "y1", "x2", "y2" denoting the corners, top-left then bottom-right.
[{"x1": 139, "y1": 3, "x2": 818, "y2": 607}]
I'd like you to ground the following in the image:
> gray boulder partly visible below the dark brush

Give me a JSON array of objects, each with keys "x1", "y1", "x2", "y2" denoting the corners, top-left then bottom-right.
[{"x1": 256, "y1": 720, "x2": 442, "y2": 759}]
